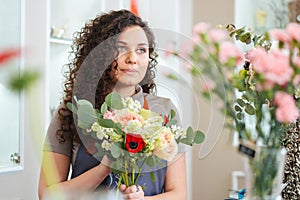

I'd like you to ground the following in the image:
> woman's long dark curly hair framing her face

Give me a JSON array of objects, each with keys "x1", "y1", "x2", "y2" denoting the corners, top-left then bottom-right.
[{"x1": 56, "y1": 10, "x2": 157, "y2": 143}]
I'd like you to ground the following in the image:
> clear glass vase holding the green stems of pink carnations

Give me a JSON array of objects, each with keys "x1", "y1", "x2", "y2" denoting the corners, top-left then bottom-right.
[{"x1": 245, "y1": 147, "x2": 286, "y2": 200}]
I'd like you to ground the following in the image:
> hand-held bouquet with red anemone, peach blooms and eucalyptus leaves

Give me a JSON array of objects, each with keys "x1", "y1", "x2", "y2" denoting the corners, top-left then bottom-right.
[{"x1": 67, "y1": 92, "x2": 204, "y2": 186}]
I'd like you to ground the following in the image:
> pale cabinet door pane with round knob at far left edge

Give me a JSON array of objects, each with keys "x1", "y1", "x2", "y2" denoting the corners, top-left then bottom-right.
[{"x1": 0, "y1": 0, "x2": 21, "y2": 173}]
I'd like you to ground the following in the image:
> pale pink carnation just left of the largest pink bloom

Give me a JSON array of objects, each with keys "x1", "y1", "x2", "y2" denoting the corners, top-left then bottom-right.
[{"x1": 219, "y1": 42, "x2": 244, "y2": 66}]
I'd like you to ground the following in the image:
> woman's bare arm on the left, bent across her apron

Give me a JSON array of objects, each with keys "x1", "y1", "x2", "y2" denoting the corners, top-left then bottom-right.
[{"x1": 38, "y1": 152, "x2": 110, "y2": 199}]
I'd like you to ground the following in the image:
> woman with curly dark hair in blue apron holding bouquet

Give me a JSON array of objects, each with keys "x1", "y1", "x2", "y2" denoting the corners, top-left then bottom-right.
[{"x1": 39, "y1": 10, "x2": 186, "y2": 200}]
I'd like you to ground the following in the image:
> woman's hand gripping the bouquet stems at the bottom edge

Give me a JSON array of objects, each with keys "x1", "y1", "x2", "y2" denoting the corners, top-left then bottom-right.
[{"x1": 120, "y1": 184, "x2": 144, "y2": 200}]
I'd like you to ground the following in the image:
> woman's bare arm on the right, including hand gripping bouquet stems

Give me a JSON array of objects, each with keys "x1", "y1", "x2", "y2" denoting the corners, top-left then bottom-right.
[{"x1": 120, "y1": 154, "x2": 187, "y2": 200}]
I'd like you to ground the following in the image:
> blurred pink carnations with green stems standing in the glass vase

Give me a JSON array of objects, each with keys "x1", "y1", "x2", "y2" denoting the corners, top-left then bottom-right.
[{"x1": 166, "y1": 23, "x2": 300, "y2": 198}]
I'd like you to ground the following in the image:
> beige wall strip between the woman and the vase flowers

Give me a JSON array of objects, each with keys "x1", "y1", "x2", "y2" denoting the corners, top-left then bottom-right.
[{"x1": 192, "y1": 0, "x2": 248, "y2": 200}]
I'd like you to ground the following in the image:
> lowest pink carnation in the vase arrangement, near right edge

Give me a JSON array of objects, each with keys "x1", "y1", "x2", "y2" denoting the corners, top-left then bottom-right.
[{"x1": 274, "y1": 92, "x2": 299, "y2": 123}]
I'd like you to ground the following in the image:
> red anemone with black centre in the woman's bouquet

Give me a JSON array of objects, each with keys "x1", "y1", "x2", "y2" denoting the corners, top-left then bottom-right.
[{"x1": 125, "y1": 133, "x2": 146, "y2": 153}]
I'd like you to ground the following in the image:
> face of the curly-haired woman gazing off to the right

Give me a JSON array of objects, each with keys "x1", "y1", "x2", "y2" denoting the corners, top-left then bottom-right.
[{"x1": 115, "y1": 26, "x2": 149, "y2": 87}]
